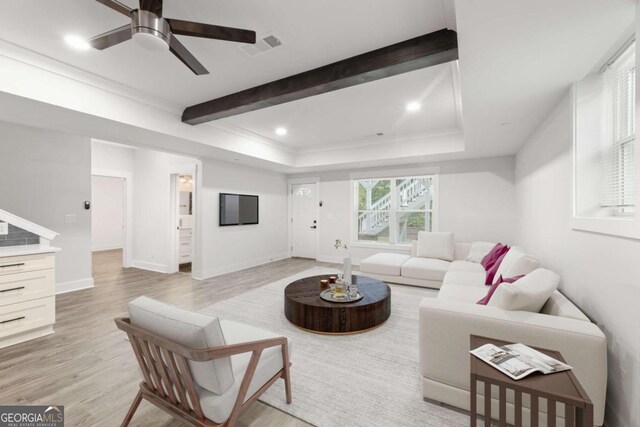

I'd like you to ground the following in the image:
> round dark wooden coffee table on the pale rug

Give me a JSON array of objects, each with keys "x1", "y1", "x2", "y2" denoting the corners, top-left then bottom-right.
[{"x1": 284, "y1": 275, "x2": 391, "y2": 334}]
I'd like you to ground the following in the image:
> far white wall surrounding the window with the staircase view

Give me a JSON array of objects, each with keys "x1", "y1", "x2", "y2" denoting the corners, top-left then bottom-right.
[{"x1": 289, "y1": 157, "x2": 516, "y2": 263}]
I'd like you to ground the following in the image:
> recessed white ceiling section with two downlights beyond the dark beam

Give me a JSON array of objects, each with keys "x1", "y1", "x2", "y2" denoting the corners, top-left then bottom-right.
[{"x1": 216, "y1": 63, "x2": 460, "y2": 152}]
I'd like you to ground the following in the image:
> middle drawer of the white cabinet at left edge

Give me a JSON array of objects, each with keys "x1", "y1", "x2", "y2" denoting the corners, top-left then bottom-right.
[{"x1": 0, "y1": 270, "x2": 56, "y2": 306}]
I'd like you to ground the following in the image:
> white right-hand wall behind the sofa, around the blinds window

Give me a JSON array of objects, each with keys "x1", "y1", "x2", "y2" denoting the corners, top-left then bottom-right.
[{"x1": 516, "y1": 96, "x2": 640, "y2": 426}]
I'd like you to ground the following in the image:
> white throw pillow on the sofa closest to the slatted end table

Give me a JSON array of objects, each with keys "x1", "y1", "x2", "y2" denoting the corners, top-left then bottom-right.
[{"x1": 487, "y1": 268, "x2": 560, "y2": 313}]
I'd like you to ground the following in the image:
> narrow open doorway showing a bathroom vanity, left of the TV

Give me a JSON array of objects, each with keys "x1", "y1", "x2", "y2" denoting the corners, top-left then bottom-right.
[{"x1": 170, "y1": 172, "x2": 196, "y2": 274}]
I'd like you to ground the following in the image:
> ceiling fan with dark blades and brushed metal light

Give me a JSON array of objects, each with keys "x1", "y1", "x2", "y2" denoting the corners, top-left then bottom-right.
[{"x1": 89, "y1": 0, "x2": 256, "y2": 75}]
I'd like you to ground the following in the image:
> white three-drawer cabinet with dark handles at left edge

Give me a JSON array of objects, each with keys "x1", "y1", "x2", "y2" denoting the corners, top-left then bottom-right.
[{"x1": 0, "y1": 252, "x2": 56, "y2": 348}]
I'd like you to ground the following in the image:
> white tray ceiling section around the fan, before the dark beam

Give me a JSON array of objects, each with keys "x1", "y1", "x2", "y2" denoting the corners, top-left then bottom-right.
[{"x1": 0, "y1": 0, "x2": 446, "y2": 106}]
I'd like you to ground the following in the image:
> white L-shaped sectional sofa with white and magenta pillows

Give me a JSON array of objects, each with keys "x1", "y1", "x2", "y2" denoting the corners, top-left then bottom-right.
[{"x1": 360, "y1": 235, "x2": 607, "y2": 426}]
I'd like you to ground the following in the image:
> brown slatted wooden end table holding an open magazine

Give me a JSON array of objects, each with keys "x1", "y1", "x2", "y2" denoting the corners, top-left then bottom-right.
[{"x1": 470, "y1": 335, "x2": 593, "y2": 427}]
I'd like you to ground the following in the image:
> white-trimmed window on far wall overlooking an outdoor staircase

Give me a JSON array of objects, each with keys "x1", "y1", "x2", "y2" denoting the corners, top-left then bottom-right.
[{"x1": 353, "y1": 175, "x2": 436, "y2": 244}]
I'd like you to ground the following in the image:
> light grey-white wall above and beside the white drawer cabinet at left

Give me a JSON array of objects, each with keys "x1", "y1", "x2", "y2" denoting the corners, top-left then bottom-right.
[{"x1": 0, "y1": 122, "x2": 93, "y2": 291}]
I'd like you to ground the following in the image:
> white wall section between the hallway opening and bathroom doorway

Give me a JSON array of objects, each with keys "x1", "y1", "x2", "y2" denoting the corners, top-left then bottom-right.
[{"x1": 132, "y1": 149, "x2": 197, "y2": 273}]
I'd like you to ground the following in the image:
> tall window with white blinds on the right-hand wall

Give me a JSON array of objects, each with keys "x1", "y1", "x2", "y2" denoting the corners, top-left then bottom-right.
[{"x1": 600, "y1": 42, "x2": 636, "y2": 214}]
